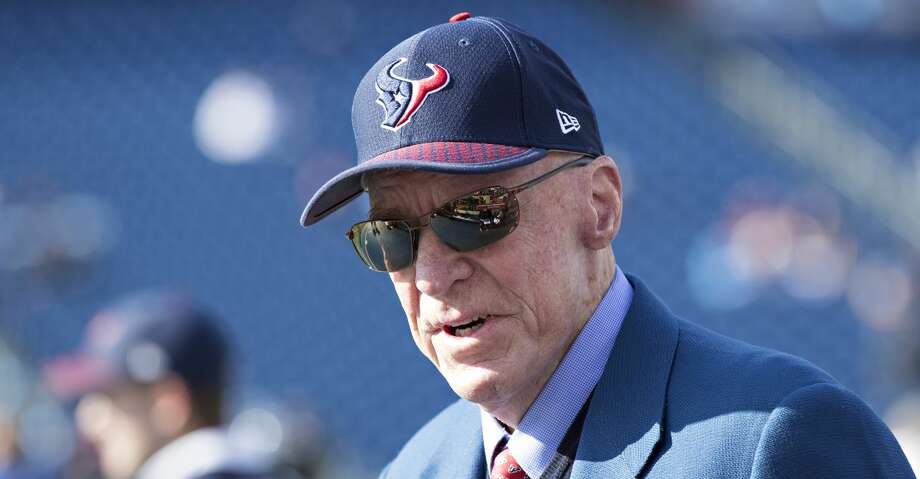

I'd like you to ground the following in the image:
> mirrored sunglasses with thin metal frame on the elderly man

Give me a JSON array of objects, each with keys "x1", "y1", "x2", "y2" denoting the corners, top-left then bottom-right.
[{"x1": 345, "y1": 156, "x2": 594, "y2": 272}]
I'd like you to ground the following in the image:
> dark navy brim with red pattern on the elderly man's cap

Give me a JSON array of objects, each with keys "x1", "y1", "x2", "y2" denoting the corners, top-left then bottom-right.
[{"x1": 300, "y1": 142, "x2": 549, "y2": 226}]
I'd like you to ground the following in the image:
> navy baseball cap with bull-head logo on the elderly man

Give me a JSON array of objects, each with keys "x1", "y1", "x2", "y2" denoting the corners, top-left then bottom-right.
[{"x1": 300, "y1": 13, "x2": 603, "y2": 226}]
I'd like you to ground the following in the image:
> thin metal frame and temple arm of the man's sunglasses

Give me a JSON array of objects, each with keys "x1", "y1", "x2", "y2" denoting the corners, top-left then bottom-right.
[{"x1": 345, "y1": 155, "x2": 596, "y2": 273}]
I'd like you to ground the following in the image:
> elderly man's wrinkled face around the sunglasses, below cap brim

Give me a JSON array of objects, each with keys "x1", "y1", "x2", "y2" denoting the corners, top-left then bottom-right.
[{"x1": 368, "y1": 154, "x2": 593, "y2": 422}]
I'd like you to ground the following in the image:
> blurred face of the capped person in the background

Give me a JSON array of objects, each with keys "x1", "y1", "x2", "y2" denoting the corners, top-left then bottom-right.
[{"x1": 77, "y1": 385, "x2": 162, "y2": 479}]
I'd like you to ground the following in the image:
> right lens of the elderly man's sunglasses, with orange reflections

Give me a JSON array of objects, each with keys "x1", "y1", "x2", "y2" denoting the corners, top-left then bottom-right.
[{"x1": 431, "y1": 186, "x2": 518, "y2": 251}]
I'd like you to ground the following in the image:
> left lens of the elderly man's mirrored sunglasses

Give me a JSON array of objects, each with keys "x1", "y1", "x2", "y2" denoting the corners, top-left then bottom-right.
[{"x1": 349, "y1": 221, "x2": 415, "y2": 271}]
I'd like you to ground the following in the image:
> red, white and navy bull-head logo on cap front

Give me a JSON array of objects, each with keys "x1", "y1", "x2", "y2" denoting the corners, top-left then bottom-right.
[{"x1": 374, "y1": 58, "x2": 450, "y2": 131}]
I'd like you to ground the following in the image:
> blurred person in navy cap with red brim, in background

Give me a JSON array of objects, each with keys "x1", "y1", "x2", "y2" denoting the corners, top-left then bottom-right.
[{"x1": 46, "y1": 292, "x2": 280, "y2": 479}]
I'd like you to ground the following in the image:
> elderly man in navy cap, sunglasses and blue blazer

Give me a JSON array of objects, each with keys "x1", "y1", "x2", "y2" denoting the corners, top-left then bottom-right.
[{"x1": 302, "y1": 14, "x2": 912, "y2": 479}]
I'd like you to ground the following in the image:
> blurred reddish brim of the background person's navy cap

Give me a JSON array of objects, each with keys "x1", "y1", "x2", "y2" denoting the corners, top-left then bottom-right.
[{"x1": 43, "y1": 353, "x2": 118, "y2": 399}]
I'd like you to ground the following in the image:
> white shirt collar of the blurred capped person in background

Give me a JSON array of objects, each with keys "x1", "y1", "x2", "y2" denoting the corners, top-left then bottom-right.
[{"x1": 135, "y1": 428, "x2": 270, "y2": 479}]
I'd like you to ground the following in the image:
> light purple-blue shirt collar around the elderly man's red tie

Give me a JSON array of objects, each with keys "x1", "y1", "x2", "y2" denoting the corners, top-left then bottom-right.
[{"x1": 480, "y1": 267, "x2": 633, "y2": 477}]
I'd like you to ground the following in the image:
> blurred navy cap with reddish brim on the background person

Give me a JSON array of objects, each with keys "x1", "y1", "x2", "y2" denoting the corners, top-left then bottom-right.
[{"x1": 45, "y1": 291, "x2": 229, "y2": 397}]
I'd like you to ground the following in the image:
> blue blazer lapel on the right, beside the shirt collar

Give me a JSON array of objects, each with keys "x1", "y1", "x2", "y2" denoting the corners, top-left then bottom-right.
[{"x1": 571, "y1": 275, "x2": 678, "y2": 479}]
